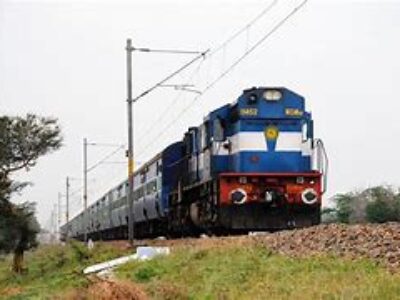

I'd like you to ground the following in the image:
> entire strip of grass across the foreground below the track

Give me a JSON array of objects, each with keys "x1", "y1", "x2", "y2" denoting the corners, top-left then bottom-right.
[{"x1": 0, "y1": 232, "x2": 400, "y2": 300}]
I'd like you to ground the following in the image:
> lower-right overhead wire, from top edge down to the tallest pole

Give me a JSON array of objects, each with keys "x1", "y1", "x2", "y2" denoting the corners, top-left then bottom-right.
[{"x1": 137, "y1": 0, "x2": 308, "y2": 158}]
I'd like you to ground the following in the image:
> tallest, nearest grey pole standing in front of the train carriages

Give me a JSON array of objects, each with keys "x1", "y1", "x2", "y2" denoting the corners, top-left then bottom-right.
[{"x1": 126, "y1": 39, "x2": 135, "y2": 244}]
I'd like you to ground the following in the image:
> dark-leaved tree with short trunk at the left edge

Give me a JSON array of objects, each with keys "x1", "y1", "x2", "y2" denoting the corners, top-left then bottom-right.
[{"x1": 0, "y1": 114, "x2": 62, "y2": 272}]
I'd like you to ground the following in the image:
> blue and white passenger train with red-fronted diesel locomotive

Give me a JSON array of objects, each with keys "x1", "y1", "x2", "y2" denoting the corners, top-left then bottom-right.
[{"x1": 60, "y1": 87, "x2": 328, "y2": 240}]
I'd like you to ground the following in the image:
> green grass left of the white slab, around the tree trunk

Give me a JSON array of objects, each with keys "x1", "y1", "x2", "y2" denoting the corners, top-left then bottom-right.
[{"x1": 0, "y1": 242, "x2": 131, "y2": 299}]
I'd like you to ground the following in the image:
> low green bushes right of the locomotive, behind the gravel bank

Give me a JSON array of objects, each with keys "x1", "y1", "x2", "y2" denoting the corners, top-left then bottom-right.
[{"x1": 322, "y1": 186, "x2": 400, "y2": 223}]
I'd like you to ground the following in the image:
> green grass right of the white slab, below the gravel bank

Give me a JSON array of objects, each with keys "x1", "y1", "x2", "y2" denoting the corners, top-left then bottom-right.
[{"x1": 118, "y1": 247, "x2": 400, "y2": 299}]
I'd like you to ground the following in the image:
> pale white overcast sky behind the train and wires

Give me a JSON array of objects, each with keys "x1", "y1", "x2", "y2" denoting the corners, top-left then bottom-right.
[{"x1": 0, "y1": 0, "x2": 400, "y2": 230}]
